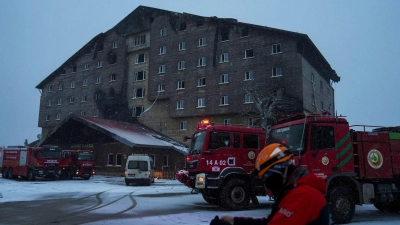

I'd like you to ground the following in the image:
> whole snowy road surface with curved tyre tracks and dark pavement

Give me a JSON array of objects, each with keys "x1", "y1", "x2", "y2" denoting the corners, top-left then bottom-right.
[{"x1": 0, "y1": 176, "x2": 400, "y2": 225}]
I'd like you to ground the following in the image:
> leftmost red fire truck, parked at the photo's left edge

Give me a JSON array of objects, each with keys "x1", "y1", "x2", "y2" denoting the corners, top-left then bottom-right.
[{"x1": 0, "y1": 146, "x2": 61, "y2": 181}]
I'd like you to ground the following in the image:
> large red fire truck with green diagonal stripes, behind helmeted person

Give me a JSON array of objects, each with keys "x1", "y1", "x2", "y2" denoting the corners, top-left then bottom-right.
[{"x1": 268, "y1": 114, "x2": 400, "y2": 223}]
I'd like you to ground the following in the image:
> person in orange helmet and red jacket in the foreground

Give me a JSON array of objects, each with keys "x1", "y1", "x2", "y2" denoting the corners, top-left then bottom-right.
[{"x1": 210, "y1": 144, "x2": 331, "y2": 225}]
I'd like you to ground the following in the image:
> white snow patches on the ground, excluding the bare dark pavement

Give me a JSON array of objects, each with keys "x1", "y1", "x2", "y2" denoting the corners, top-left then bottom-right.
[{"x1": 0, "y1": 175, "x2": 400, "y2": 225}]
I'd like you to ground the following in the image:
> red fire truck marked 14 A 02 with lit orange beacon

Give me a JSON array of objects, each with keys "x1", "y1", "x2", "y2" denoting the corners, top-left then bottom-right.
[{"x1": 176, "y1": 120, "x2": 266, "y2": 210}]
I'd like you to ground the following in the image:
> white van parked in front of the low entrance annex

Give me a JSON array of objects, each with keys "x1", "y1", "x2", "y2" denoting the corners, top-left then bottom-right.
[{"x1": 125, "y1": 154, "x2": 154, "y2": 186}]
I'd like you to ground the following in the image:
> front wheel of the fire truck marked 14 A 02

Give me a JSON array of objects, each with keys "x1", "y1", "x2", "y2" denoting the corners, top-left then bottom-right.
[{"x1": 220, "y1": 178, "x2": 250, "y2": 210}]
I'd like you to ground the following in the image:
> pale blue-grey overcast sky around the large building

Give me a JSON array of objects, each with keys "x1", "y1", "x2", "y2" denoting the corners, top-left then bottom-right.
[{"x1": 0, "y1": 0, "x2": 400, "y2": 146}]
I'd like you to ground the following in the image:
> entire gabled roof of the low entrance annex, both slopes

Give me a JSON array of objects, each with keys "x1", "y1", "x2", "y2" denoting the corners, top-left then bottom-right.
[{"x1": 37, "y1": 114, "x2": 187, "y2": 154}]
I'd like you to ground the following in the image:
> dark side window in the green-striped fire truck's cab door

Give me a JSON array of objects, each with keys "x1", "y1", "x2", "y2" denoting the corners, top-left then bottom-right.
[{"x1": 311, "y1": 126, "x2": 335, "y2": 150}]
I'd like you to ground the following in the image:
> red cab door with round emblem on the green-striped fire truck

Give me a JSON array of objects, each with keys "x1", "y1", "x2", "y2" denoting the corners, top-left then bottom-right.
[{"x1": 306, "y1": 124, "x2": 337, "y2": 179}]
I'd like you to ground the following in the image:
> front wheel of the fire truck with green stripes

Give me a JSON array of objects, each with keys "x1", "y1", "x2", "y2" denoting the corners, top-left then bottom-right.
[{"x1": 329, "y1": 187, "x2": 356, "y2": 224}]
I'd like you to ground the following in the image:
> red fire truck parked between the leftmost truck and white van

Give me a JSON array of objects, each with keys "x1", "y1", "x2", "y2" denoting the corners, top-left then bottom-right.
[{"x1": 60, "y1": 150, "x2": 94, "y2": 180}]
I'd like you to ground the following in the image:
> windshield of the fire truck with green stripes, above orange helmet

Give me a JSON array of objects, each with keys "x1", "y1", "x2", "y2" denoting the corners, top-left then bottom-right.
[{"x1": 268, "y1": 124, "x2": 304, "y2": 154}]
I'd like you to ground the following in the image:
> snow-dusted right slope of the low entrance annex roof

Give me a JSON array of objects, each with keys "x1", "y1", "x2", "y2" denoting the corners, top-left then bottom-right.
[{"x1": 37, "y1": 114, "x2": 187, "y2": 154}]
